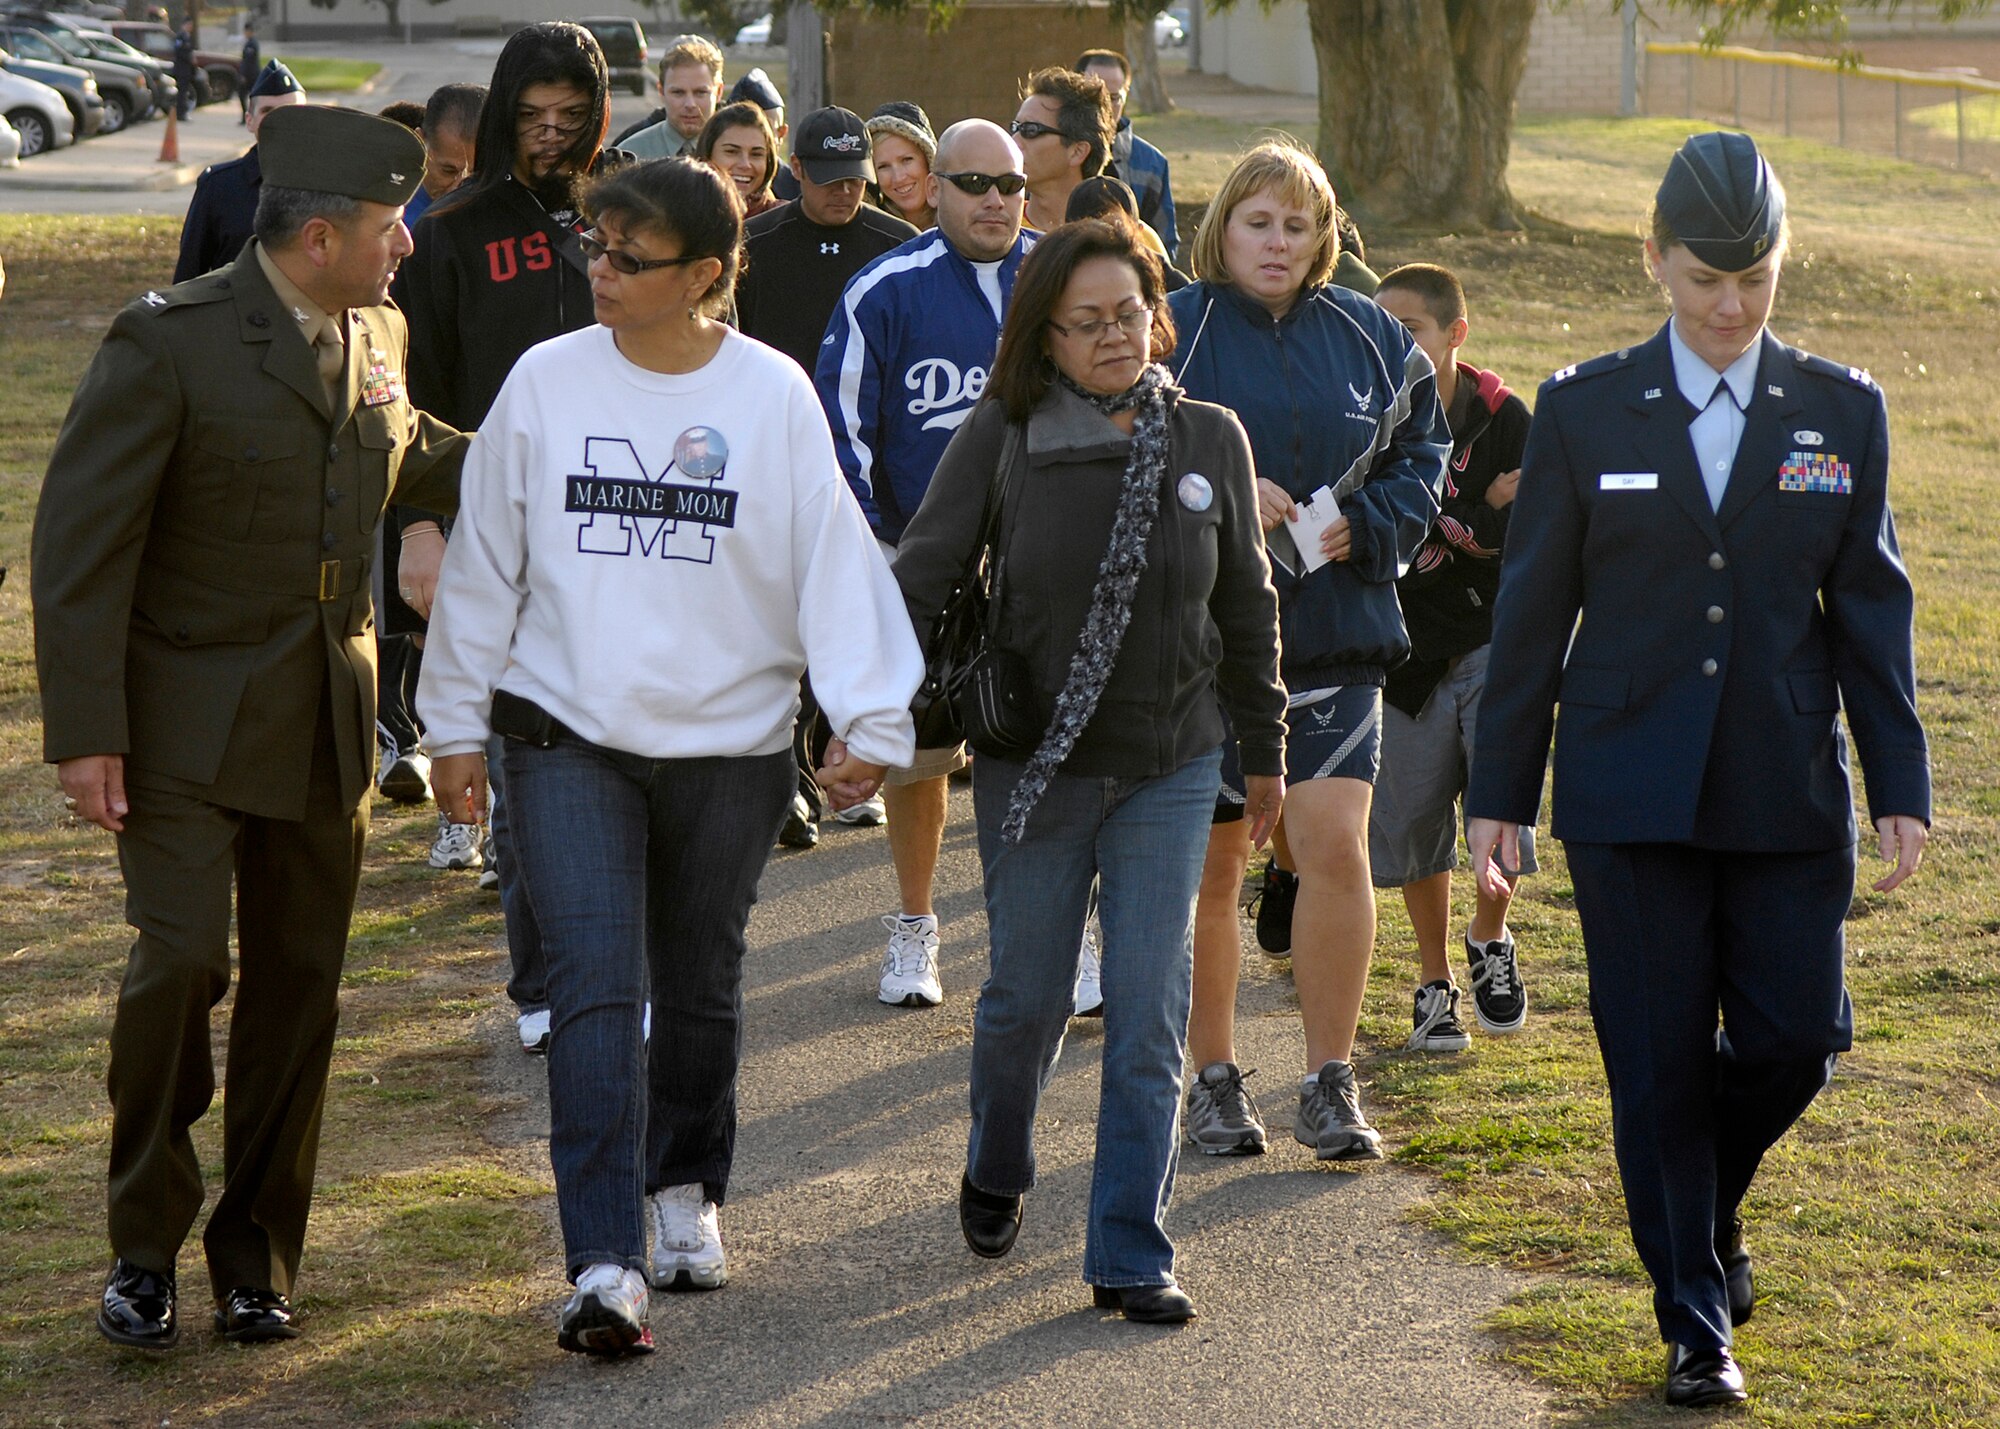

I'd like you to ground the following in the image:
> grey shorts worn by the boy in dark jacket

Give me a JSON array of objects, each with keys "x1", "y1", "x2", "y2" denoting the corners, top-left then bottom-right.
[{"x1": 1368, "y1": 644, "x2": 1536, "y2": 889}]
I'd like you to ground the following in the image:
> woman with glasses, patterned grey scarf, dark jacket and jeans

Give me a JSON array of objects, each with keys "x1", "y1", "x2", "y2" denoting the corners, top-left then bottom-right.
[{"x1": 896, "y1": 222, "x2": 1284, "y2": 1323}]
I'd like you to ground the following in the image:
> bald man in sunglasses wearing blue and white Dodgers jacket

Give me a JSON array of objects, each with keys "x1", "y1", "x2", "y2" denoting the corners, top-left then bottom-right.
[{"x1": 814, "y1": 120, "x2": 1032, "y2": 1007}]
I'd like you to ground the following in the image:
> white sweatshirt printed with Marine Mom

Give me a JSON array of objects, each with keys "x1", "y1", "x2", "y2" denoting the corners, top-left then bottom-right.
[{"x1": 416, "y1": 326, "x2": 924, "y2": 769}]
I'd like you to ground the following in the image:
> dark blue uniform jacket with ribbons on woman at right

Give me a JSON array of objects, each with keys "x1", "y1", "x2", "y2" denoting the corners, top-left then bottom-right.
[{"x1": 1466, "y1": 328, "x2": 1930, "y2": 853}]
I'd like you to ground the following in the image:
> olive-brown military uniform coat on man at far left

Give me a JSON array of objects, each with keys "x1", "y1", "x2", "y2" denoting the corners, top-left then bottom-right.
[{"x1": 34, "y1": 250, "x2": 470, "y2": 819}]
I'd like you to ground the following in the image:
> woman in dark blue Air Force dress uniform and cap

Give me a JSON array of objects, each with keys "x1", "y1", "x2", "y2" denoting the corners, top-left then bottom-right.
[{"x1": 1466, "y1": 134, "x2": 1930, "y2": 1405}]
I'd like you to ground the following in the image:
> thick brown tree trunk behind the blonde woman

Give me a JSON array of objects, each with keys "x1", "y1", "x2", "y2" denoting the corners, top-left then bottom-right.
[{"x1": 1306, "y1": 0, "x2": 1536, "y2": 228}]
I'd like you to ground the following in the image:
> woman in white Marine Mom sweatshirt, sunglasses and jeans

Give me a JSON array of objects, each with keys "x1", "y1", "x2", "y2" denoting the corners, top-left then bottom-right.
[{"x1": 418, "y1": 158, "x2": 922, "y2": 1355}]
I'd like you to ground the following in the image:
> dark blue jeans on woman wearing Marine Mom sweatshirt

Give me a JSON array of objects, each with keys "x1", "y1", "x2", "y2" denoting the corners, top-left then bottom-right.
[{"x1": 502, "y1": 735, "x2": 798, "y2": 1281}]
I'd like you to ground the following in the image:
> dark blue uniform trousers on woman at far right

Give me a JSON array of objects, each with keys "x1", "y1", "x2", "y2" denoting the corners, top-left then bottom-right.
[{"x1": 1566, "y1": 843, "x2": 1854, "y2": 1349}]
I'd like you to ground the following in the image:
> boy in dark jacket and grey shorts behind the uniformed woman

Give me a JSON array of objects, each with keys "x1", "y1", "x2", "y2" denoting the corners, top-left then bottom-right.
[{"x1": 1368, "y1": 262, "x2": 1536, "y2": 1051}]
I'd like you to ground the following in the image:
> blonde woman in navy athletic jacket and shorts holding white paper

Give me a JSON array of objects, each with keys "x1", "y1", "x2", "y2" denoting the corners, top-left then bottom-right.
[{"x1": 1168, "y1": 144, "x2": 1452, "y2": 1161}]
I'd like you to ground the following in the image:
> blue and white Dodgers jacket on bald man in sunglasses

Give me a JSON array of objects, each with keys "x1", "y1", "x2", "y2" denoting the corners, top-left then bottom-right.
[{"x1": 812, "y1": 228, "x2": 1034, "y2": 544}]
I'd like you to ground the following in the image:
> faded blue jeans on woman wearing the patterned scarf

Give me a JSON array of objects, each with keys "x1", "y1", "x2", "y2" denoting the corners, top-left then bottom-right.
[{"x1": 966, "y1": 749, "x2": 1222, "y2": 1287}]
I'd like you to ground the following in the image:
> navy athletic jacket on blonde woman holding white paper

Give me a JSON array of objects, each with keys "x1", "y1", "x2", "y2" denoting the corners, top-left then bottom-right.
[{"x1": 1166, "y1": 282, "x2": 1452, "y2": 690}]
